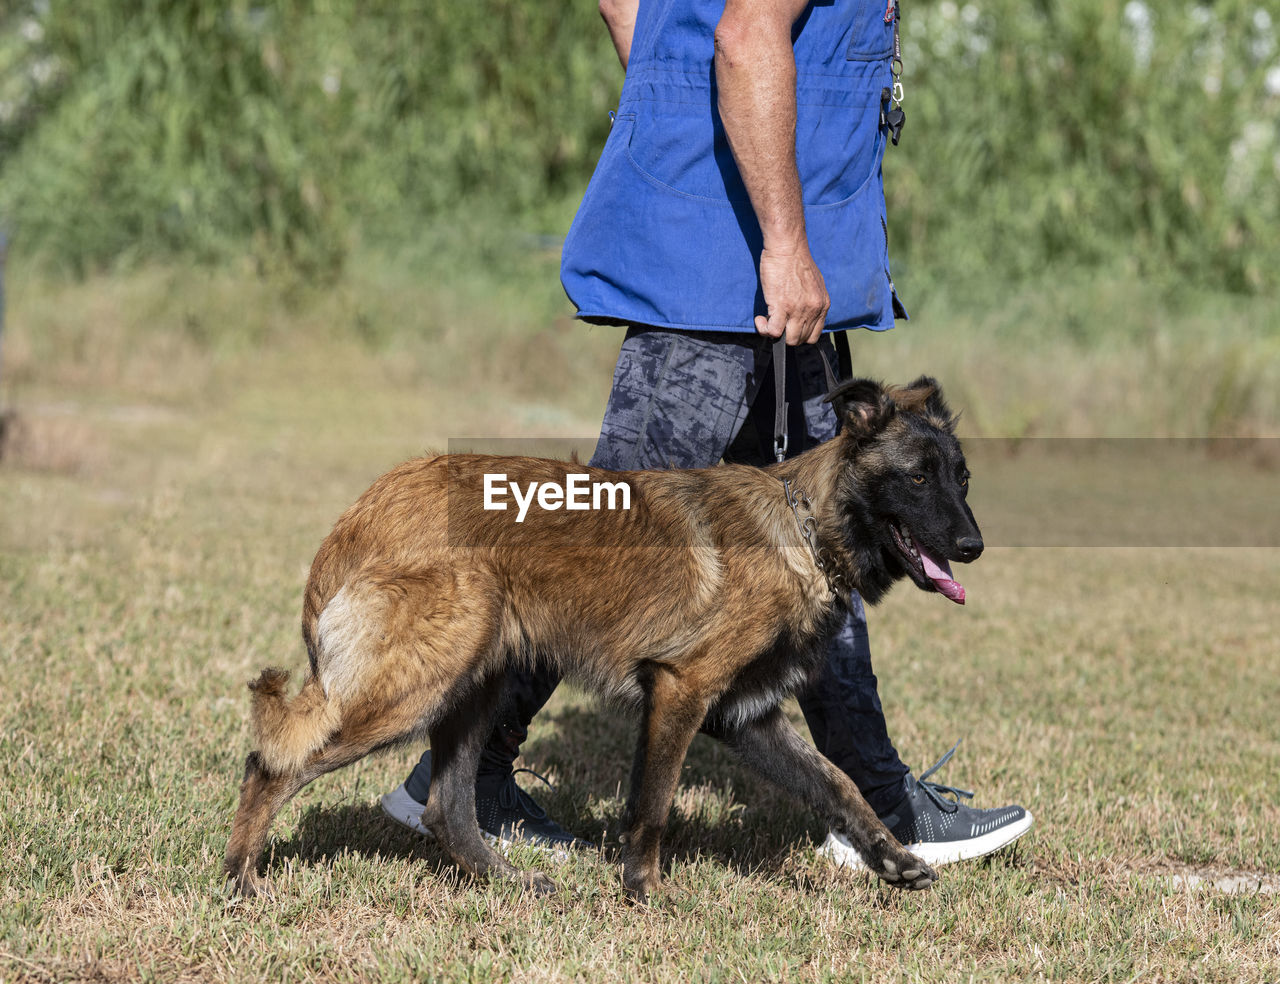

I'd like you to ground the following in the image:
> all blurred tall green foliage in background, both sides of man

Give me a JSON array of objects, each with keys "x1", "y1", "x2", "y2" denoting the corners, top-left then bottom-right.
[{"x1": 0, "y1": 0, "x2": 1280, "y2": 293}]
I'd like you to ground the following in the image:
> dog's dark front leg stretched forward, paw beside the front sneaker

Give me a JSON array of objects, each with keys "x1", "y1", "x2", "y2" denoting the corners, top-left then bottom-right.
[{"x1": 703, "y1": 708, "x2": 938, "y2": 888}]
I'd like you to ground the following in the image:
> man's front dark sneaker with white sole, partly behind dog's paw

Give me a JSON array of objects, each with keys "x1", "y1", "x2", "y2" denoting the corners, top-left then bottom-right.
[{"x1": 818, "y1": 742, "x2": 1034, "y2": 870}]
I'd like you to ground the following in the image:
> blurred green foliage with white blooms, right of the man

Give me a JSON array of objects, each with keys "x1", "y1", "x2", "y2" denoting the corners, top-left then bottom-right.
[{"x1": 884, "y1": 0, "x2": 1280, "y2": 293}]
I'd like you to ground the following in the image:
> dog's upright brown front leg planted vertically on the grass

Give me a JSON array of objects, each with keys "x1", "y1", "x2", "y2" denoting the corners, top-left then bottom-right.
[{"x1": 622, "y1": 665, "x2": 707, "y2": 903}]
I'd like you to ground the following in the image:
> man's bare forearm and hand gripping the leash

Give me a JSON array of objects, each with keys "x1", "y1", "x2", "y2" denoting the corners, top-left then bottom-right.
[{"x1": 716, "y1": 0, "x2": 831, "y2": 345}]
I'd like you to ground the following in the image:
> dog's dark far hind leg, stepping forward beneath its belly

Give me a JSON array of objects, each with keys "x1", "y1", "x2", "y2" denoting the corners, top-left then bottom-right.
[{"x1": 422, "y1": 671, "x2": 556, "y2": 893}]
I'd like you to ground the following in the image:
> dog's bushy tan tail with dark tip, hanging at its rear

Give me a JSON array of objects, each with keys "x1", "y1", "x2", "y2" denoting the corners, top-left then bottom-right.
[{"x1": 248, "y1": 669, "x2": 342, "y2": 774}]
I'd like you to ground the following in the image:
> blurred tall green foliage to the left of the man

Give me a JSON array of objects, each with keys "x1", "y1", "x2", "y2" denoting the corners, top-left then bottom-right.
[{"x1": 0, "y1": 0, "x2": 621, "y2": 274}]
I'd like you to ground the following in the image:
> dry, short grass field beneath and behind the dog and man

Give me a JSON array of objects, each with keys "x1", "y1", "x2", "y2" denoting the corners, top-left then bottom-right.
[{"x1": 0, "y1": 263, "x2": 1280, "y2": 981}]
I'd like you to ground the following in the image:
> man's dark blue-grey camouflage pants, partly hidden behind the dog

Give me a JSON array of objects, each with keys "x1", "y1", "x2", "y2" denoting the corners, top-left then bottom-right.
[{"x1": 406, "y1": 326, "x2": 908, "y2": 813}]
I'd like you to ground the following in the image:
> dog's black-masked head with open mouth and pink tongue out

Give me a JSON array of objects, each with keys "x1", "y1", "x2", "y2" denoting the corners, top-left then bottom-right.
[{"x1": 827, "y1": 376, "x2": 983, "y2": 604}]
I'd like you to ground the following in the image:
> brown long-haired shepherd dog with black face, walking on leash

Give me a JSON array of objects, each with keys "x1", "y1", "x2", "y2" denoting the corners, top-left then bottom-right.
[{"x1": 225, "y1": 376, "x2": 983, "y2": 902}]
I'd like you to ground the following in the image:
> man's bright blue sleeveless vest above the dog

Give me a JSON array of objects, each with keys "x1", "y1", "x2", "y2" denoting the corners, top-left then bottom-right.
[{"x1": 561, "y1": 0, "x2": 905, "y2": 333}]
